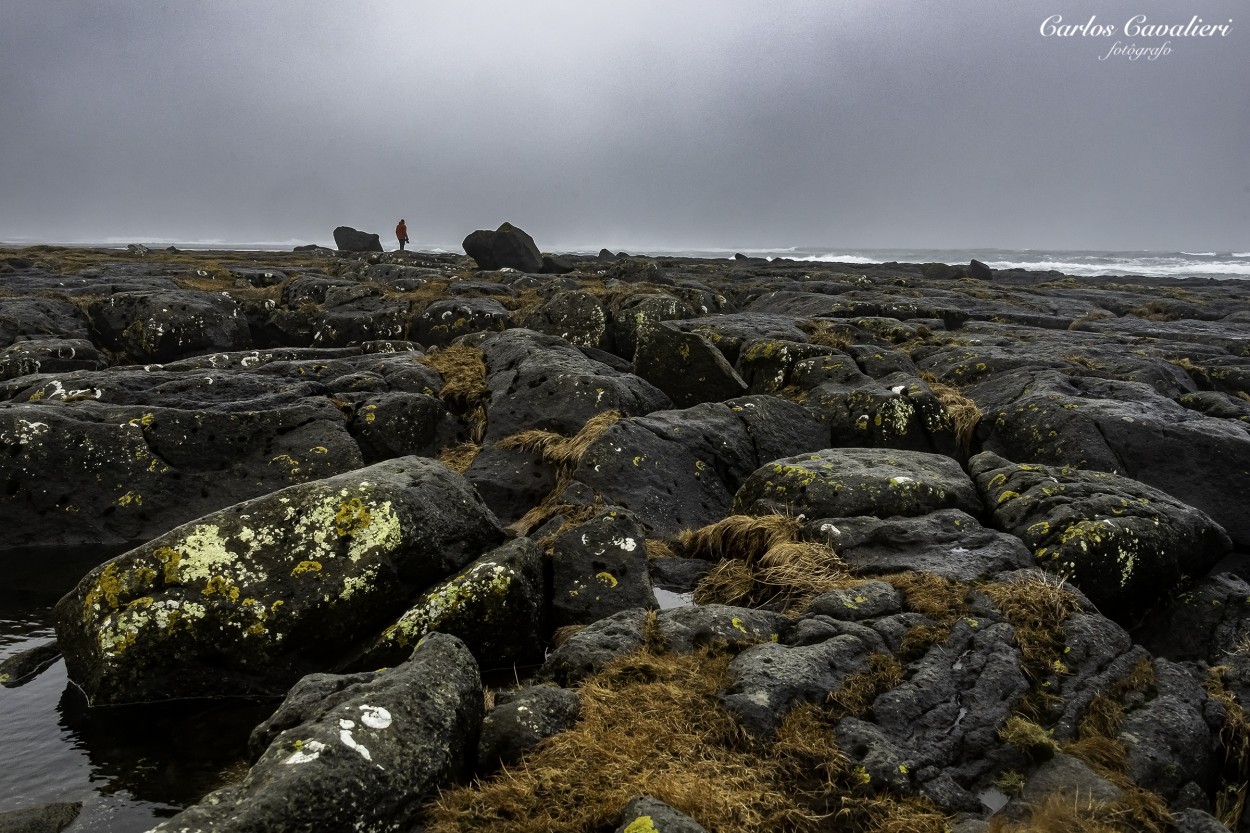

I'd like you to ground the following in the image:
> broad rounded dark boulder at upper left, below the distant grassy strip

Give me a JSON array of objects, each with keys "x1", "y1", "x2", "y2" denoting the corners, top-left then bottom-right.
[{"x1": 90, "y1": 290, "x2": 251, "y2": 364}]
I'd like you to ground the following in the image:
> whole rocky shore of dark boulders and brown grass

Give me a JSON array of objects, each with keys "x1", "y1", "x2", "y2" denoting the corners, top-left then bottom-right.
[{"x1": 0, "y1": 235, "x2": 1250, "y2": 833}]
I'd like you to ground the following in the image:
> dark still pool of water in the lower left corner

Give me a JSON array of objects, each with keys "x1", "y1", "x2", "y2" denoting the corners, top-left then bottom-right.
[{"x1": 0, "y1": 553, "x2": 274, "y2": 833}]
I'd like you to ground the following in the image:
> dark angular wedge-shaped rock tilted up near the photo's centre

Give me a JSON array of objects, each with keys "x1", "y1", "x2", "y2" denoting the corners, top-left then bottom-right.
[{"x1": 634, "y1": 323, "x2": 746, "y2": 408}]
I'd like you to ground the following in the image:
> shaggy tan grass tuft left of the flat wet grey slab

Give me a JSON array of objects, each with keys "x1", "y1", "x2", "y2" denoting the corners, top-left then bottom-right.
[{"x1": 679, "y1": 515, "x2": 860, "y2": 613}]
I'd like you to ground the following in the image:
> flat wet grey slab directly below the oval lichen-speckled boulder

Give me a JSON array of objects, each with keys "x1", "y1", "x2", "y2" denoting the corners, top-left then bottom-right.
[{"x1": 804, "y1": 509, "x2": 1034, "y2": 582}]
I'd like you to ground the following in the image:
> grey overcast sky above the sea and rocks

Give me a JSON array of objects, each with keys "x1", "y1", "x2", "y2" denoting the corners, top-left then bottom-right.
[{"x1": 0, "y1": 0, "x2": 1250, "y2": 251}]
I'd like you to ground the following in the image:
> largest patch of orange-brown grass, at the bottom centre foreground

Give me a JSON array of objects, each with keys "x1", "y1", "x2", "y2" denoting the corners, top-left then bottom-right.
[{"x1": 428, "y1": 650, "x2": 951, "y2": 833}]
